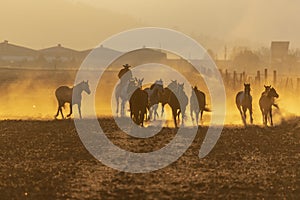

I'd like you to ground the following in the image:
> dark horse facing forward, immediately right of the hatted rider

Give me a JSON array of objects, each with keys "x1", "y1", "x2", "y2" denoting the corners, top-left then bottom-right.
[{"x1": 128, "y1": 79, "x2": 148, "y2": 126}]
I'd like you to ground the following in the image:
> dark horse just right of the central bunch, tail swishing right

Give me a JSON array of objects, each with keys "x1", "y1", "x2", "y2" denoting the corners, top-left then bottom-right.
[{"x1": 190, "y1": 86, "x2": 211, "y2": 125}]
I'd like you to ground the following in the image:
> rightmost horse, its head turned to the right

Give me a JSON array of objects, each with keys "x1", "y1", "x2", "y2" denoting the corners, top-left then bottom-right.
[{"x1": 259, "y1": 88, "x2": 279, "y2": 126}]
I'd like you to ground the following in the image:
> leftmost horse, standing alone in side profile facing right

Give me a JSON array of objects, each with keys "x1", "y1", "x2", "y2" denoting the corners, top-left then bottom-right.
[{"x1": 55, "y1": 81, "x2": 91, "y2": 119}]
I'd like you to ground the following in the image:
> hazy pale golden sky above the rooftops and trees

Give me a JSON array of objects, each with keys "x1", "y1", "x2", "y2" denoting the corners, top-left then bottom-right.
[{"x1": 0, "y1": 0, "x2": 300, "y2": 50}]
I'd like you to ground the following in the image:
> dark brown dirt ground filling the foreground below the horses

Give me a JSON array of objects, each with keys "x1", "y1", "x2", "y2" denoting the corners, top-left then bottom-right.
[{"x1": 0, "y1": 118, "x2": 300, "y2": 199}]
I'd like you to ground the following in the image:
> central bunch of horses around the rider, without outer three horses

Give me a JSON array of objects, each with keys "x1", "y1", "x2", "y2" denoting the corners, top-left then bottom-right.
[{"x1": 115, "y1": 78, "x2": 204, "y2": 127}]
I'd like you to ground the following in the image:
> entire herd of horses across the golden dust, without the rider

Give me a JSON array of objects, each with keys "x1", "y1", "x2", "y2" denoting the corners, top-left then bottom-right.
[{"x1": 55, "y1": 78, "x2": 279, "y2": 127}]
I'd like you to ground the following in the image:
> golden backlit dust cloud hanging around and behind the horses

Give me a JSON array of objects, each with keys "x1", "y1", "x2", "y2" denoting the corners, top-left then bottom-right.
[{"x1": 0, "y1": 66, "x2": 300, "y2": 126}]
